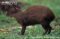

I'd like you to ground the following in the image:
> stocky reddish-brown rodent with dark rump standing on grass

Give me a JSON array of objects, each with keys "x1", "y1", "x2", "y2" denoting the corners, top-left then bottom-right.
[{"x1": 7, "y1": 6, "x2": 55, "y2": 35}]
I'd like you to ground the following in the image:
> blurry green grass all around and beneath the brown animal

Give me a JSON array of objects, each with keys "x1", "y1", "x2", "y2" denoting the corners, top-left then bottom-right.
[{"x1": 0, "y1": 0, "x2": 60, "y2": 39}]
